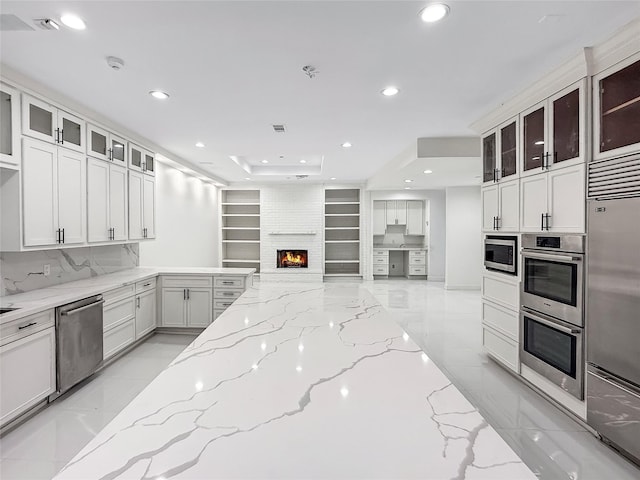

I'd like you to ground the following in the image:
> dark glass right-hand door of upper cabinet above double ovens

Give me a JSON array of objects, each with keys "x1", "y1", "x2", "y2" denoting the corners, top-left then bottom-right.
[{"x1": 551, "y1": 88, "x2": 580, "y2": 163}]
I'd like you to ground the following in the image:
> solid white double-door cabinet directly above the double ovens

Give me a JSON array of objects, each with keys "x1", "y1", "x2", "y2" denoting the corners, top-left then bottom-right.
[{"x1": 520, "y1": 164, "x2": 585, "y2": 233}]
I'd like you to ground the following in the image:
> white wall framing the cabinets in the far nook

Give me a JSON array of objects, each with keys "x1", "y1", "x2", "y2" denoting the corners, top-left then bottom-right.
[{"x1": 370, "y1": 190, "x2": 444, "y2": 282}]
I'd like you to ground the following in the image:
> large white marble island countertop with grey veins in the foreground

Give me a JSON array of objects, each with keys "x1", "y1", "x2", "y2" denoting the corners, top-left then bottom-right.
[{"x1": 55, "y1": 282, "x2": 536, "y2": 480}]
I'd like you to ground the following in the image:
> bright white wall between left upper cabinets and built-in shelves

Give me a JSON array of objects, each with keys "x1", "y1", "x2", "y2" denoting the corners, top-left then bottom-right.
[{"x1": 140, "y1": 162, "x2": 219, "y2": 267}]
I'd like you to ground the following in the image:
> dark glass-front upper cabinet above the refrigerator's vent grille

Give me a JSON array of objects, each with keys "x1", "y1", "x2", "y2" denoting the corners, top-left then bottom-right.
[{"x1": 593, "y1": 55, "x2": 640, "y2": 159}]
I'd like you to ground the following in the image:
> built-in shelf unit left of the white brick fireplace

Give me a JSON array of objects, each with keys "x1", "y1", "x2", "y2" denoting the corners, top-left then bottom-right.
[{"x1": 220, "y1": 189, "x2": 260, "y2": 272}]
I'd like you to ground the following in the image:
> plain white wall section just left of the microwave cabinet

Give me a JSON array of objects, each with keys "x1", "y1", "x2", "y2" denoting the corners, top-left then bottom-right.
[{"x1": 445, "y1": 187, "x2": 482, "y2": 290}]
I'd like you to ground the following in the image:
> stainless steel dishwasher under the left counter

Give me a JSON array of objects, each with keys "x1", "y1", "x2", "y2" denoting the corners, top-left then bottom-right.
[{"x1": 50, "y1": 295, "x2": 104, "y2": 399}]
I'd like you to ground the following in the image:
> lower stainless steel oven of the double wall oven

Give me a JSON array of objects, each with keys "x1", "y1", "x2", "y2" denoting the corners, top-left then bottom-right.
[{"x1": 520, "y1": 309, "x2": 584, "y2": 400}]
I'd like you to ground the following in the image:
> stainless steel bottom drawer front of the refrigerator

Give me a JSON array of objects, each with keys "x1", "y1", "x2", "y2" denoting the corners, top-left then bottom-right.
[{"x1": 587, "y1": 366, "x2": 640, "y2": 461}]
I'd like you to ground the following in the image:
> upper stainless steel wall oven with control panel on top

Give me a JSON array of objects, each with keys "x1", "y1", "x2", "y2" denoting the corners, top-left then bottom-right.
[{"x1": 520, "y1": 234, "x2": 584, "y2": 327}]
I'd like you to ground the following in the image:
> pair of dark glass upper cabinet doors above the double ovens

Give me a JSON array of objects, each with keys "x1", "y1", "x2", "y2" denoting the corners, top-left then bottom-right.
[{"x1": 520, "y1": 80, "x2": 586, "y2": 176}]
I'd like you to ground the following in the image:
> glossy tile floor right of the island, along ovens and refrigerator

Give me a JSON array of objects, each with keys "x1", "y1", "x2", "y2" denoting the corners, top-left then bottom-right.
[{"x1": 365, "y1": 280, "x2": 640, "y2": 480}]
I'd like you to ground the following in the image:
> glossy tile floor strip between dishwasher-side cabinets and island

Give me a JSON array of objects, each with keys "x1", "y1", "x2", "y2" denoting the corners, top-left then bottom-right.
[{"x1": 0, "y1": 334, "x2": 195, "y2": 480}]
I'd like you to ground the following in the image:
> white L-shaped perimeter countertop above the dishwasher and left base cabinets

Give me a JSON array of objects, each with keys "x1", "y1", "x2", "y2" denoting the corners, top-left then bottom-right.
[{"x1": 0, "y1": 267, "x2": 255, "y2": 324}]
